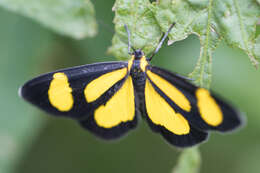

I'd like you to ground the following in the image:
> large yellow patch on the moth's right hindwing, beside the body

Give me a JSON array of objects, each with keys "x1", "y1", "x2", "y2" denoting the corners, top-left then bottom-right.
[{"x1": 145, "y1": 80, "x2": 190, "y2": 135}]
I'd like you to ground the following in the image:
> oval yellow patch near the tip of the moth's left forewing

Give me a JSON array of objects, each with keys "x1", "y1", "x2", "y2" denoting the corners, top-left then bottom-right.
[{"x1": 48, "y1": 72, "x2": 73, "y2": 111}]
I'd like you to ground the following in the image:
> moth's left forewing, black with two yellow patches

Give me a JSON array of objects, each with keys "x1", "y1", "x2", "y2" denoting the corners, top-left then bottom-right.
[{"x1": 19, "y1": 62, "x2": 128, "y2": 119}]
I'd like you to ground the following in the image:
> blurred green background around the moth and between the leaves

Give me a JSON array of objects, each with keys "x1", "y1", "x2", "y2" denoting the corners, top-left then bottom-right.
[{"x1": 0, "y1": 1, "x2": 260, "y2": 173}]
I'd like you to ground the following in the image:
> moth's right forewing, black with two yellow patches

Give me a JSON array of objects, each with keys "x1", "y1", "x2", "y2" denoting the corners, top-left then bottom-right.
[{"x1": 147, "y1": 67, "x2": 241, "y2": 132}]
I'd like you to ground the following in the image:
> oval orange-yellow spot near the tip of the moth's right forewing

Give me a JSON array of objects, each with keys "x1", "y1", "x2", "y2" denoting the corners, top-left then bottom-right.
[{"x1": 196, "y1": 88, "x2": 223, "y2": 126}]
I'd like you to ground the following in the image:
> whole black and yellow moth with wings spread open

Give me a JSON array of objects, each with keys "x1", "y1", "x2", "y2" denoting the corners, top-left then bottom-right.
[{"x1": 19, "y1": 23, "x2": 241, "y2": 147}]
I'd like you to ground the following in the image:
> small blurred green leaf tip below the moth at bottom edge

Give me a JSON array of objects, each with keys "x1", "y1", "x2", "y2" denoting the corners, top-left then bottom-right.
[{"x1": 172, "y1": 147, "x2": 201, "y2": 173}]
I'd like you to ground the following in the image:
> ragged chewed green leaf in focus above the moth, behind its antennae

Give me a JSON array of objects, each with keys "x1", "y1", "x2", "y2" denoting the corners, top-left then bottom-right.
[{"x1": 109, "y1": 0, "x2": 260, "y2": 88}]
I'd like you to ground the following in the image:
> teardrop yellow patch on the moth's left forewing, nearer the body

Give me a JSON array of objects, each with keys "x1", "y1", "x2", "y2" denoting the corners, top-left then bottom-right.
[{"x1": 84, "y1": 68, "x2": 127, "y2": 102}]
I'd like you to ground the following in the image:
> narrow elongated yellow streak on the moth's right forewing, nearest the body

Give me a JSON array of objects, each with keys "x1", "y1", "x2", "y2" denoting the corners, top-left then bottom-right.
[{"x1": 147, "y1": 71, "x2": 191, "y2": 112}]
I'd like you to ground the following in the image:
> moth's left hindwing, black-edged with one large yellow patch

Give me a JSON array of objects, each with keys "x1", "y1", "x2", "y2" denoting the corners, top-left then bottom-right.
[{"x1": 80, "y1": 76, "x2": 137, "y2": 139}]
